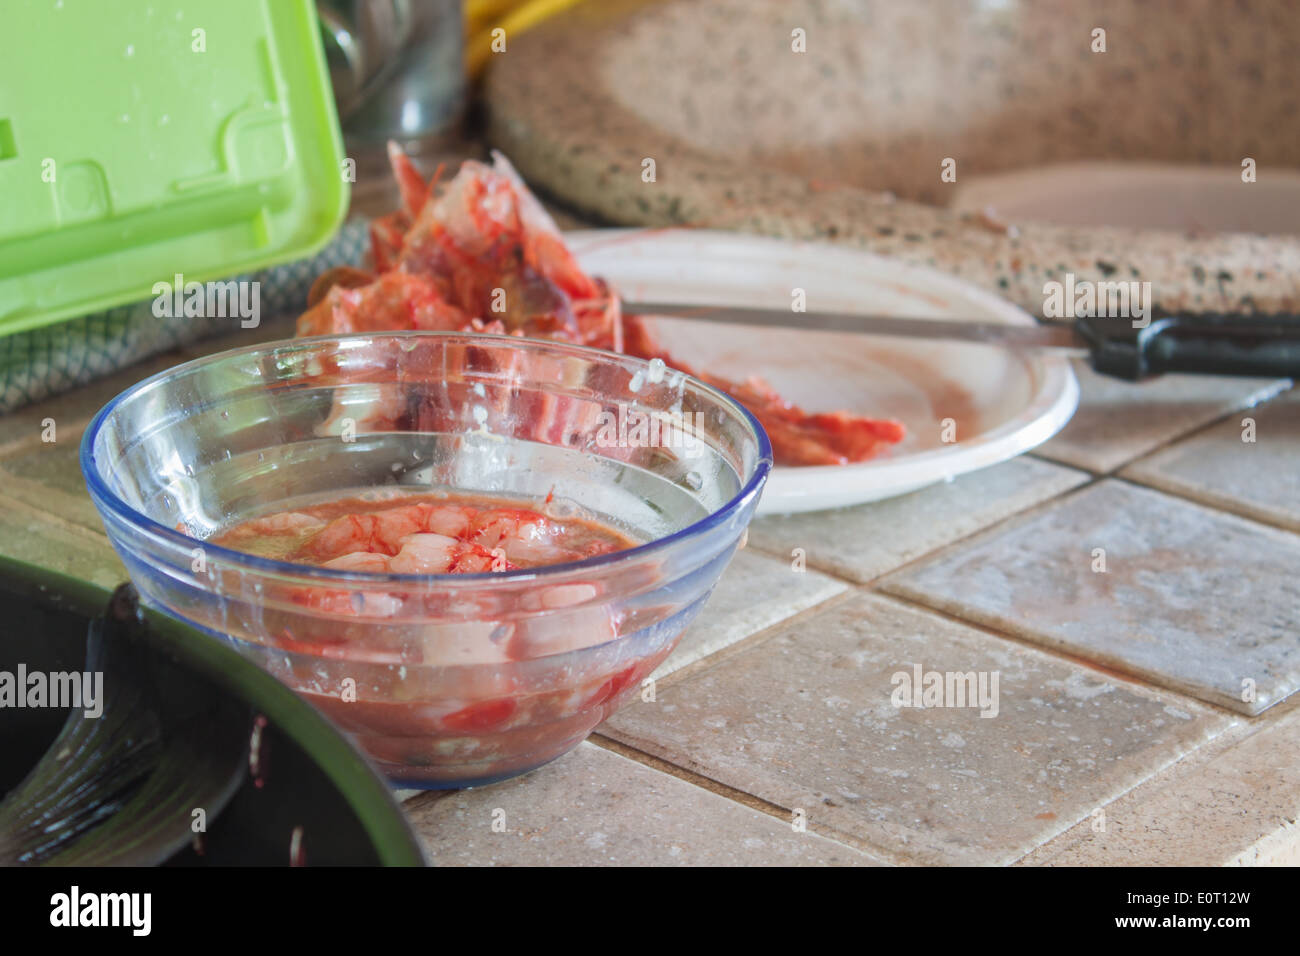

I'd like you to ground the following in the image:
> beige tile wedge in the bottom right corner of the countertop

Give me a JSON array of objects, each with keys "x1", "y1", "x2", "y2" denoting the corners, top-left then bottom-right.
[{"x1": 1022, "y1": 708, "x2": 1300, "y2": 866}]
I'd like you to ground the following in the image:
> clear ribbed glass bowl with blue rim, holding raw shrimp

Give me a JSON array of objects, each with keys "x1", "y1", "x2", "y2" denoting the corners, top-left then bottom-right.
[{"x1": 81, "y1": 332, "x2": 772, "y2": 788}]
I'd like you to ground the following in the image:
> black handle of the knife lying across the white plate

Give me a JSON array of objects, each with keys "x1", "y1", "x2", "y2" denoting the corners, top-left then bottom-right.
[{"x1": 1075, "y1": 312, "x2": 1300, "y2": 381}]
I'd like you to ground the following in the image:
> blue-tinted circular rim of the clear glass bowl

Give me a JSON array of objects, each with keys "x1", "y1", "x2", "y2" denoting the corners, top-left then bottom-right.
[{"x1": 78, "y1": 330, "x2": 772, "y2": 587}]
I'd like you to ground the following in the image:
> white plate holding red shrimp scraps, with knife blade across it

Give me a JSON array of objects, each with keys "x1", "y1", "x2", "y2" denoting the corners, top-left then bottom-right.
[{"x1": 566, "y1": 229, "x2": 1079, "y2": 514}]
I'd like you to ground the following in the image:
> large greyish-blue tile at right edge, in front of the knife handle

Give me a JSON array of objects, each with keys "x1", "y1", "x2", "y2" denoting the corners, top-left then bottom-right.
[{"x1": 883, "y1": 480, "x2": 1300, "y2": 714}]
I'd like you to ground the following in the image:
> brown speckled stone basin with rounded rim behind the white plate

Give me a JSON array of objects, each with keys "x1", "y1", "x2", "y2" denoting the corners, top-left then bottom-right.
[{"x1": 488, "y1": 0, "x2": 1300, "y2": 321}]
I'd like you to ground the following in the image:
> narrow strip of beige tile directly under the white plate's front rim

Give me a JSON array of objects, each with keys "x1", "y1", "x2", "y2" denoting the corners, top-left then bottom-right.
[{"x1": 749, "y1": 458, "x2": 1087, "y2": 583}]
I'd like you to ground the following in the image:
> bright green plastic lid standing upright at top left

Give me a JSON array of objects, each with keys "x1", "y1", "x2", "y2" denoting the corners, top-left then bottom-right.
[{"x1": 0, "y1": 0, "x2": 348, "y2": 336}]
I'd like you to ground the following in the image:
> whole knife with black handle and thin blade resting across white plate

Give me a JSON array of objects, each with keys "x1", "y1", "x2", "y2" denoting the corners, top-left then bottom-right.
[{"x1": 623, "y1": 300, "x2": 1300, "y2": 381}]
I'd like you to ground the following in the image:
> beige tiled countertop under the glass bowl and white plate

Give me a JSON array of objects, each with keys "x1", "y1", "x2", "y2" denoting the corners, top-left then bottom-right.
[{"x1": 0, "y1": 314, "x2": 1300, "y2": 865}]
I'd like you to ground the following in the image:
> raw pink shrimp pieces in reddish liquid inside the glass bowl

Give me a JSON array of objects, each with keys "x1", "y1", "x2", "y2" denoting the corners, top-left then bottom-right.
[{"x1": 212, "y1": 493, "x2": 667, "y2": 780}]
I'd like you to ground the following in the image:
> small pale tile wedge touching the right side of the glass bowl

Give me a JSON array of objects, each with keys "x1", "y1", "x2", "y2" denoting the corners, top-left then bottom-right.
[{"x1": 654, "y1": 550, "x2": 849, "y2": 679}]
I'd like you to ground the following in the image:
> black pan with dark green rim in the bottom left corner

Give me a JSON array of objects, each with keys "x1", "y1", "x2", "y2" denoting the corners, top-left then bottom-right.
[{"x1": 0, "y1": 557, "x2": 424, "y2": 866}]
